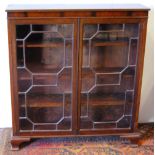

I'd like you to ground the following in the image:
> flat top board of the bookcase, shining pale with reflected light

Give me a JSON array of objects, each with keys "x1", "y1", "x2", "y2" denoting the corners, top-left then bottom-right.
[{"x1": 6, "y1": 4, "x2": 149, "y2": 12}]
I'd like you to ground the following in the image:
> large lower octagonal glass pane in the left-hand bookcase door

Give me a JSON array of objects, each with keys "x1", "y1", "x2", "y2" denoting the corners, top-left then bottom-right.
[{"x1": 27, "y1": 86, "x2": 63, "y2": 123}]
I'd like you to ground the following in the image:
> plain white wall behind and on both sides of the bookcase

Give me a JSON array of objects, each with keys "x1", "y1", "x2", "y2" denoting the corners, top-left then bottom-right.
[{"x1": 0, "y1": 0, "x2": 154, "y2": 128}]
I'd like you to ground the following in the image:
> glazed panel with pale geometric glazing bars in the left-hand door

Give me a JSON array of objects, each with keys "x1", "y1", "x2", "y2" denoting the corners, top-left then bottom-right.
[{"x1": 15, "y1": 19, "x2": 77, "y2": 133}]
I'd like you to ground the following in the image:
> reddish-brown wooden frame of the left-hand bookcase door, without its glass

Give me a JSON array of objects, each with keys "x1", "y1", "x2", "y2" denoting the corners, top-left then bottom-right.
[{"x1": 8, "y1": 18, "x2": 78, "y2": 137}]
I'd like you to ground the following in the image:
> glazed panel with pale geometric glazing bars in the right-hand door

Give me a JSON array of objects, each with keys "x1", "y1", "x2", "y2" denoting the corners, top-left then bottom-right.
[{"x1": 79, "y1": 19, "x2": 140, "y2": 132}]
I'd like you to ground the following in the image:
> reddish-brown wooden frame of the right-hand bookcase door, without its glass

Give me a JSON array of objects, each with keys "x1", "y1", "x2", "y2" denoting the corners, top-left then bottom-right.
[{"x1": 77, "y1": 17, "x2": 147, "y2": 135}]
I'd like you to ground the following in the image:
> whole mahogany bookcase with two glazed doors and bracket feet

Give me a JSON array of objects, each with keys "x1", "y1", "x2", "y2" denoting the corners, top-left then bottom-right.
[{"x1": 7, "y1": 5, "x2": 149, "y2": 150}]
